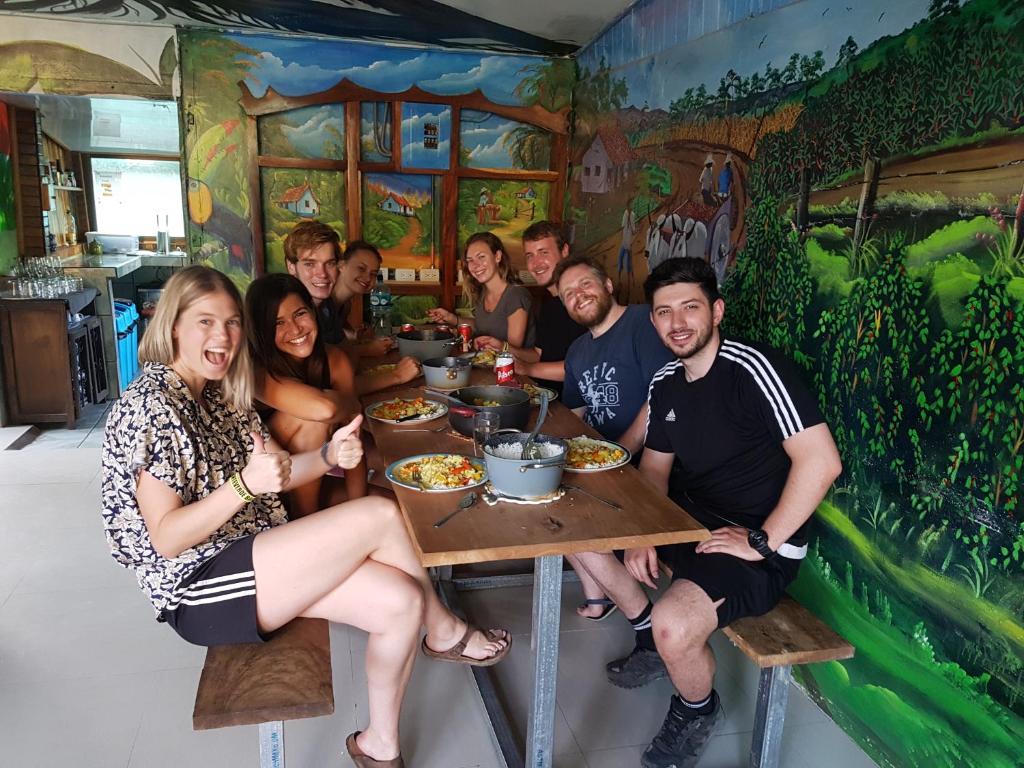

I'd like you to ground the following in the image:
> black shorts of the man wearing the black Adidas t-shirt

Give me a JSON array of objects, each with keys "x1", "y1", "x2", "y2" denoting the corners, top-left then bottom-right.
[{"x1": 657, "y1": 544, "x2": 802, "y2": 628}]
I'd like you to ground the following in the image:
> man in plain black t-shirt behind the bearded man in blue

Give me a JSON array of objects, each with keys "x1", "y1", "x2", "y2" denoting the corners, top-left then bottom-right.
[{"x1": 473, "y1": 221, "x2": 586, "y2": 394}]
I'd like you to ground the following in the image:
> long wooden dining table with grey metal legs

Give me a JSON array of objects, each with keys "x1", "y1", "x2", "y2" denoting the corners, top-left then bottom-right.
[{"x1": 362, "y1": 359, "x2": 710, "y2": 768}]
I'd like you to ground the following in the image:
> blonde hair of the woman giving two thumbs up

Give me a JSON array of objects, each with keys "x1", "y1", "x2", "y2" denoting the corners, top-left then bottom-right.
[{"x1": 138, "y1": 266, "x2": 253, "y2": 411}]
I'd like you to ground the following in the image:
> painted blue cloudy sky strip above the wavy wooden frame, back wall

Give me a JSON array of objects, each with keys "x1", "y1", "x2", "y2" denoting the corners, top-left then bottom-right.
[{"x1": 229, "y1": 35, "x2": 545, "y2": 105}]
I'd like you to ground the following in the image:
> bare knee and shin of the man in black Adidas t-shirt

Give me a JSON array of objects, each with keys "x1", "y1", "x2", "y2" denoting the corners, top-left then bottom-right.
[{"x1": 651, "y1": 581, "x2": 723, "y2": 701}]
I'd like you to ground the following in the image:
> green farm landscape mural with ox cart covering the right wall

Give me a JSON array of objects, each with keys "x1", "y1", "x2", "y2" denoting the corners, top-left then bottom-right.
[{"x1": 568, "y1": 0, "x2": 1024, "y2": 768}]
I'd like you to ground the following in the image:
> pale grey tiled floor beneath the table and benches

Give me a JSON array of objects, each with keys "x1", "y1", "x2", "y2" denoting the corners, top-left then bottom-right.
[{"x1": 0, "y1": 411, "x2": 872, "y2": 768}]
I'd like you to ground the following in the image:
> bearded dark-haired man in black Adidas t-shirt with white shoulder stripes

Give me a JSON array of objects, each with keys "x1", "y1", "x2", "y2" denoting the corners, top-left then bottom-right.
[{"x1": 580, "y1": 258, "x2": 842, "y2": 768}]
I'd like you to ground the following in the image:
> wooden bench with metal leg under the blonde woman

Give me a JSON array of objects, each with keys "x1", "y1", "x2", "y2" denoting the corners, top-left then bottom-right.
[{"x1": 193, "y1": 618, "x2": 334, "y2": 768}]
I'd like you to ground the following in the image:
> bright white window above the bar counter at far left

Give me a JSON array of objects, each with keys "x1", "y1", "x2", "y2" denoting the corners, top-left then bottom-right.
[{"x1": 92, "y1": 158, "x2": 185, "y2": 238}]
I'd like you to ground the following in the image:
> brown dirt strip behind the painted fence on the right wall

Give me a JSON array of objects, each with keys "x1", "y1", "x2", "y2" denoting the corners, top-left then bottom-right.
[{"x1": 811, "y1": 137, "x2": 1024, "y2": 205}]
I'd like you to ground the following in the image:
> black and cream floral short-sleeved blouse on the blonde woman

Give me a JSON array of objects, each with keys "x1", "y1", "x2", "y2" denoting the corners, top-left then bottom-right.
[{"x1": 102, "y1": 362, "x2": 287, "y2": 616}]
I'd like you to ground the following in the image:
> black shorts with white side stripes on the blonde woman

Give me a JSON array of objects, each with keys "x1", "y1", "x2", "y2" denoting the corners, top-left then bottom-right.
[{"x1": 160, "y1": 535, "x2": 263, "y2": 645}]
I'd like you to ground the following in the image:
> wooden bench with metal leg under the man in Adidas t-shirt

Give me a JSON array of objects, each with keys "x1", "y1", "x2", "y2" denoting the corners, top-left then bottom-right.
[{"x1": 722, "y1": 596, "x2": 854, "y2": 768}]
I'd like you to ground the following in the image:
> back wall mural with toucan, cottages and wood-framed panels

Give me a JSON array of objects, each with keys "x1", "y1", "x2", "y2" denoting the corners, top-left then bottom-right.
[{"x1": 181, "y1": 32, "x2": 574, "y2": 287}]
